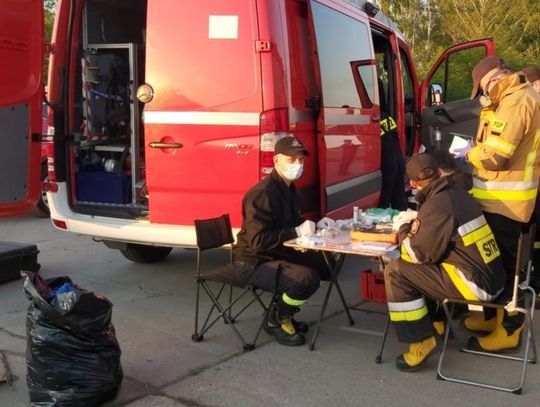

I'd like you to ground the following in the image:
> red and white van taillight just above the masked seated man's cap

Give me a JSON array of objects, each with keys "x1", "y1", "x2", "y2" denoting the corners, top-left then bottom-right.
[{"x1": 259, "y1": 107, "x2": 289, "y2": 178}]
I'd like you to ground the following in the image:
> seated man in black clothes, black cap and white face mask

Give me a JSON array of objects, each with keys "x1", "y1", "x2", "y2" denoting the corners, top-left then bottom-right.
[{"x1": 233, "y1": 137, "x2": 328, "y2": 346}]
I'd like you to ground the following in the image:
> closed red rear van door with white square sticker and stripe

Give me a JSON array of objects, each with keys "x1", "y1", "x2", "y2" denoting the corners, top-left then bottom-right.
[{"x1": 144, "y1": 0, "x2": 262, "y2": 225}]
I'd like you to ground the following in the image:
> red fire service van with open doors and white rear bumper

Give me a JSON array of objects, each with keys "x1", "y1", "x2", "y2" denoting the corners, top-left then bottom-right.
[{"x1": 0, "y1": 0, "x2": 494, "y2": 262}]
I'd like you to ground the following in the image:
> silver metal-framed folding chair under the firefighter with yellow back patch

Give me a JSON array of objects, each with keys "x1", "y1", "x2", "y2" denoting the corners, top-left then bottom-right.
[{"x1": 437, "y1": 225, "x2": 536, "y2": 394}]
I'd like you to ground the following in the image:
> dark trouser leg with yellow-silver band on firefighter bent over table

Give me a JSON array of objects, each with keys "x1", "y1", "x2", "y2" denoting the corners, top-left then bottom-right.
[{"x1": 384, "y1": 259, "x2": 463, "y2": 343}]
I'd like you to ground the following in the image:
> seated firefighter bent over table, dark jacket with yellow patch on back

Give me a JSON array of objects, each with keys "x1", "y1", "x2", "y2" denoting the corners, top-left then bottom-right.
[{"x1": 384, "y1": 154, "x2": 504, "y2": 372}]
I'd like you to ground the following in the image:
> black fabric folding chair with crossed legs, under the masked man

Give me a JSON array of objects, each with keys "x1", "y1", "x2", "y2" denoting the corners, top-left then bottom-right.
[{"x1": 191, "y1": 214, "x2": 275, "y2": 350}]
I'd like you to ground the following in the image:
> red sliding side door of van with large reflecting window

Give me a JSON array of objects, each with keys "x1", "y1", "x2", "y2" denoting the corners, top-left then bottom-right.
[{"x1": 310, "y1": 0, "x2": 381, "y2": 218}]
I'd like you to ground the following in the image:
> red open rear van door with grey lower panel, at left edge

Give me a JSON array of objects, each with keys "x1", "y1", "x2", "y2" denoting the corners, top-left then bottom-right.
[{"x1": 0, "y1": 0, "x2": 44, "y2": 216}]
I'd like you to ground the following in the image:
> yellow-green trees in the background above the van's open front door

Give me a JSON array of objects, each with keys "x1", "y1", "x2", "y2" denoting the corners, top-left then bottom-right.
[{"x1": 380, "y1": 0, "x2": 540, "y2": 78}]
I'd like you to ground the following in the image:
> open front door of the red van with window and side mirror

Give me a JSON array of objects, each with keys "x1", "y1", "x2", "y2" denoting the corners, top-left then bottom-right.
[{"x1": 419, "y1": 39, "x2": 495, "y2": 152}]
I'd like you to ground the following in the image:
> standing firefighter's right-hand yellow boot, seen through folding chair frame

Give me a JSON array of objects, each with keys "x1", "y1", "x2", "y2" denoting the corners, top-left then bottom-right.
[{"x1": 467, "y1": 309, "x2": 524, "y2": 353}]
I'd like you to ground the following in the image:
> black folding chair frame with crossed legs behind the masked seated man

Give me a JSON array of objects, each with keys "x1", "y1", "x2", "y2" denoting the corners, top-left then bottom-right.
[{"x1": 191, "y1": 214, "x2": 275, "y2": 351}]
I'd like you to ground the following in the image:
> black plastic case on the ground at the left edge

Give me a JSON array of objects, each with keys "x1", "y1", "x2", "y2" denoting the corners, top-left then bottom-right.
[{"x1": 0, "y1": 241, "x2": 39, "y2": 284}]
